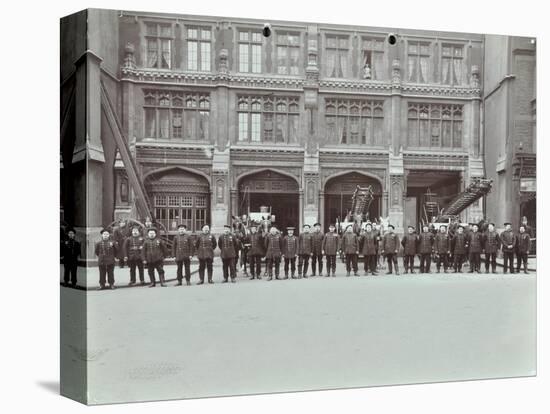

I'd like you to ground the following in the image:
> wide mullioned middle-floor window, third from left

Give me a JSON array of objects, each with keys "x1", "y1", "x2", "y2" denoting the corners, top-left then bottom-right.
[{"x1": 325, "y1": 99, "x2": 384, "y2": 146}]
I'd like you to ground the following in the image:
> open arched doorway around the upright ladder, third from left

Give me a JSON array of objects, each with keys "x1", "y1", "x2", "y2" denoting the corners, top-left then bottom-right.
[{"x1": 323, "y1": 172, "x2": 382, "y2": 229}]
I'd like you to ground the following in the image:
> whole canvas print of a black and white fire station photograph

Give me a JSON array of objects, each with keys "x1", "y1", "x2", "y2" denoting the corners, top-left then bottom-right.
[{"x1": 59, "y1": 9, "x2": 540, "y2": 405}]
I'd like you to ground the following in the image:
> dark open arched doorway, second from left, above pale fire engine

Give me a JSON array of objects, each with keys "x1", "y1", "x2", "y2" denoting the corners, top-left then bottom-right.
[{"x1": 238, "y1": 170, "x2": 300, "y2": 231}]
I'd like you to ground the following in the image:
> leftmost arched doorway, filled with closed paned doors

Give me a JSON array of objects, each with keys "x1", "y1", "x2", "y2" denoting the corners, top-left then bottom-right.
[{"x1": 145, "y1": 168, "x2": 210, "y2": 234}]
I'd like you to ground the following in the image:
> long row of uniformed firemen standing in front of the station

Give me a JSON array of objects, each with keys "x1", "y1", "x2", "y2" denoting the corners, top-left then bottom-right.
[{"x1": 62, "y1": 218, "x2": 531, "y2": 289}]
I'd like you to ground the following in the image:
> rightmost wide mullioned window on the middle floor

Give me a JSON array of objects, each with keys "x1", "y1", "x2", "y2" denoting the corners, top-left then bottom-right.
[{"x1": 408, "y1": 103, "x2": 463, "y2": 148}]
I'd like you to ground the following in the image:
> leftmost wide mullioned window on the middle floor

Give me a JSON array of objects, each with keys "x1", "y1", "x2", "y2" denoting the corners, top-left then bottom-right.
[{"x1": 143, "y1": 90, "x2": 210, "y2": 140}]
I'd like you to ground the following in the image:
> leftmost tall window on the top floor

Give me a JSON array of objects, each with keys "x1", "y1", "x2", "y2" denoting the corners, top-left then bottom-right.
[{"x1": 145, "y1": 23, "x2": 174, "y2": 69}]
